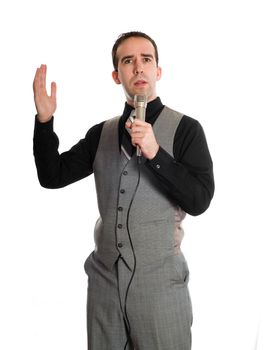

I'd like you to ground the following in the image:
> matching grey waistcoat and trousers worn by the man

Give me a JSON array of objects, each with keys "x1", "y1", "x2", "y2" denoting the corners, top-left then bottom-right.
[{"x1": 85, "y1": 107, "x2": 192, "y2": 350}]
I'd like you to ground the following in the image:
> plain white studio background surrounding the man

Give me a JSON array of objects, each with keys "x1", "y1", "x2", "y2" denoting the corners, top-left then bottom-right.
[{"x1": 0, "y1": 0, "x2": 267, "y2": 350}]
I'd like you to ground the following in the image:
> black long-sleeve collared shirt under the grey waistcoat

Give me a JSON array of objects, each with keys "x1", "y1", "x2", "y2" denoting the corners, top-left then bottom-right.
[{"x1": 34, "y1": 97, "x2": 214, "y2": 215}]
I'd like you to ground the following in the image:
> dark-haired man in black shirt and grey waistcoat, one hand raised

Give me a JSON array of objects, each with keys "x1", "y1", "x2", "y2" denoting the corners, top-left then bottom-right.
[{"x1": 34, "y1": 32, "x2": 214, "y2": 350}]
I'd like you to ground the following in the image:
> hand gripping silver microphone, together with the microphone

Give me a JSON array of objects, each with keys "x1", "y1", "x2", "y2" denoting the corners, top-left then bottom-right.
[{"x1": 126, "y1": 95, "x2": 159, "y2": 159}]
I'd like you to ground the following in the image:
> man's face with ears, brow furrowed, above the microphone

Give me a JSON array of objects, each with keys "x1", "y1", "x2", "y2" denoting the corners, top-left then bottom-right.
[{"x1": 112, "y1": 37, "x2": 161, "y2": 106}]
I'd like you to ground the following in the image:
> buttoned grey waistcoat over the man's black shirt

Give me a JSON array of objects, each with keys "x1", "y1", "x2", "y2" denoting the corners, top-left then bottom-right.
[{"x1": 93, "y1": 107, "x2": 185, "y2": 269}]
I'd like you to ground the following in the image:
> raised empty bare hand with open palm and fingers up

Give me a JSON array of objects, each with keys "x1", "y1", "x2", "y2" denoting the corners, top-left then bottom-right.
[{"x1": 33, "y1": 64, "x2": 57, "y2": 123}]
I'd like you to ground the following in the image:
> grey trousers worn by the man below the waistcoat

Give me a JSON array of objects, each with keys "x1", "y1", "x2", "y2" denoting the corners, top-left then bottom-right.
[{"x1": 85, "y1": 253, "x2": 192, "y2": 350}]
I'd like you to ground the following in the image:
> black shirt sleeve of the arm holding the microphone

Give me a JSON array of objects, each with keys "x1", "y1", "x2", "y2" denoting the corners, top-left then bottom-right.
[{"x1": 147, "y1": 116, "x2": 214, "y2": 215}]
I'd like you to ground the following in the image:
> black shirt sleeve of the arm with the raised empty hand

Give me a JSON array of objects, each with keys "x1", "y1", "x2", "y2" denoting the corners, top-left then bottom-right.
[{"x1": 33, "y1": 118, "x2": 103, "y2": 188}]
